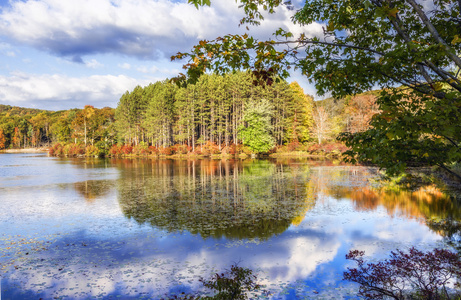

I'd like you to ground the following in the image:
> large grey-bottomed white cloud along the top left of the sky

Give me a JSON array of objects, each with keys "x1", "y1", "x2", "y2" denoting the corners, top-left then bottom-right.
[{"x1": 0, "y1": 0, "x2": 244, "y2": 62}]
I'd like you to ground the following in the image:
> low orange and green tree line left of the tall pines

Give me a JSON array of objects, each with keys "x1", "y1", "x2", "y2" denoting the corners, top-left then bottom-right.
[{"x1": 0, "y1": 105, "x2": 115, "y2": 150}]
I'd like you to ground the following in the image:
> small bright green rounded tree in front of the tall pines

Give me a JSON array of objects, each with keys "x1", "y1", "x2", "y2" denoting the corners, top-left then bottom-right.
[{"x1": 239, "y1": 99, "x2": 275, "y2": 153}]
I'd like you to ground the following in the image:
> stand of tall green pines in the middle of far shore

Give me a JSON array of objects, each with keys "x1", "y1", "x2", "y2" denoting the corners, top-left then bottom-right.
[{"x1": 115, "y1": 72, "x2": 313, "y2": 152}]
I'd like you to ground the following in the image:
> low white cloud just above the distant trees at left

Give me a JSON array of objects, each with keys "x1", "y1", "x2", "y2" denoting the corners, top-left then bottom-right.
[{"x1": 0, "y1": 72, "x2": 150, "y2": 109}]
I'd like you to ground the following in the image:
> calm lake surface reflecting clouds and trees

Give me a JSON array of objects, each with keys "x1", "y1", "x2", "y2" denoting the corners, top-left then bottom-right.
[{"x1": 0, "y1": 154, "x2": 461, "y2": 300}]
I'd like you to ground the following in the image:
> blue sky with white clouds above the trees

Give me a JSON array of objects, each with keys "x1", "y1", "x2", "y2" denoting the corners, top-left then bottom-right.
[{"x1": 0, "y1": 0, "x2": 322, "y2": 110}]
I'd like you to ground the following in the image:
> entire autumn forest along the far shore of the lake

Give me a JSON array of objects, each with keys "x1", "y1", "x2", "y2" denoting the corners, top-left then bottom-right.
[{"x1": 0, "y1": 72, "x2": 377, "y2": 156}]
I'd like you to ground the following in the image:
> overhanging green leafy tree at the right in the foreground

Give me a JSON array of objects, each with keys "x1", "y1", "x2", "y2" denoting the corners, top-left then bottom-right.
[{"x1": 173, "y1": 0, "x2": 461, "y2": 178}]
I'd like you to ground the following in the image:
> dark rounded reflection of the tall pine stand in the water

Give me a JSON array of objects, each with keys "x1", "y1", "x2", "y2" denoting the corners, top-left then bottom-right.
[{"x1": 117, "y1": 160, "x2": 315, "y2": 239}]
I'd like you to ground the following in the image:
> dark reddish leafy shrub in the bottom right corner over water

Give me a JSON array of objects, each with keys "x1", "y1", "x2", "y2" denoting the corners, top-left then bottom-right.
[{"x1": 344, "y1": 248, "x2": 461, "y2": 299}]
